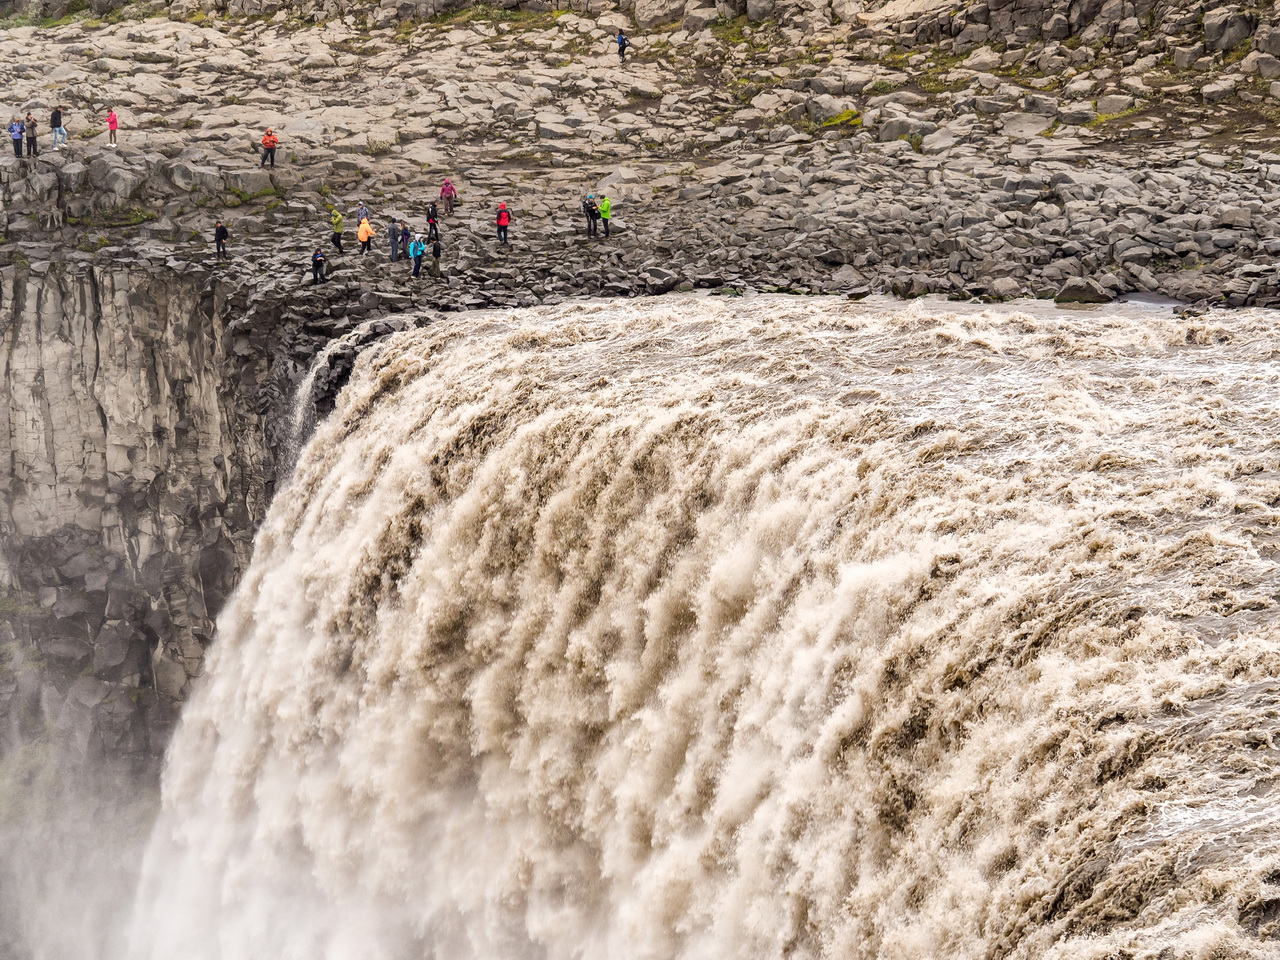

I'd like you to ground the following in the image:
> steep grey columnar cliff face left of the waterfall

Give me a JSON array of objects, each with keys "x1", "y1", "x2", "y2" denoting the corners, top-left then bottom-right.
[{"x1": 0, "y1": 264, "x2": 270, "y2": 754}]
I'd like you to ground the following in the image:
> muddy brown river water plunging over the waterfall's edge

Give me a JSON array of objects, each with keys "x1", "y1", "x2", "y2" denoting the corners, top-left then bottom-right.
[{"x1": 131, "y1": 298, "x2": 1280, "y2": 960}]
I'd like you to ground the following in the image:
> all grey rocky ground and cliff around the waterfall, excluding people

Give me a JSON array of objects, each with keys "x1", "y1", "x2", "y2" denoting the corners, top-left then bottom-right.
[{"x1": 0, "y1": 0, "x2": 1280, "y2": 758}]
